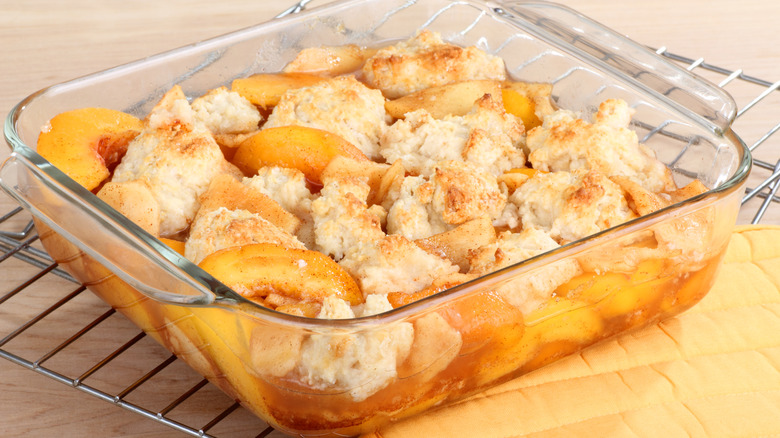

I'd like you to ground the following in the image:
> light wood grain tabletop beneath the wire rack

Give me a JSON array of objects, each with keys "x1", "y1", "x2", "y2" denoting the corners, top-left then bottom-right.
[{"x1": 0, "y1": 0, "x2": 780, "y2": 437}]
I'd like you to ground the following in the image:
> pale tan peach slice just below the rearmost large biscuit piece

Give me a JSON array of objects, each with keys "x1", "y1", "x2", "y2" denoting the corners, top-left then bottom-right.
[{"x1": 385, "y1": 80, "x2": 502, "y2": 119}]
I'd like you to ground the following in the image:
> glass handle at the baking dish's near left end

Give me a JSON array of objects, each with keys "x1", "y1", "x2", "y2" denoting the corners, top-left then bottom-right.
[{"x1": 0, "y1": 151, "x2": 232, "y2": 305}]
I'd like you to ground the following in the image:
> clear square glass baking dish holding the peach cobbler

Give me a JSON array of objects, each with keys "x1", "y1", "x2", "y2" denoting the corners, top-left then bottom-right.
[{"x1": 0, "y1": 0, "x2": 751, "y2": 436}]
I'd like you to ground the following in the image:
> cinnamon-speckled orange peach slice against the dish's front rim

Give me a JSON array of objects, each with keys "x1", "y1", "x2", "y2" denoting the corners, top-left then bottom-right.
[{"x1": 199, "y1": 243, "x2": 363, "y2": 305}]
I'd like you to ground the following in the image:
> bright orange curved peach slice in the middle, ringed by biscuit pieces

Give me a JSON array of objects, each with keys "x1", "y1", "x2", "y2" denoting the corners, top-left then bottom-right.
[{"x1": 233, "y1": 125, "x2": 368, "y2": 184}]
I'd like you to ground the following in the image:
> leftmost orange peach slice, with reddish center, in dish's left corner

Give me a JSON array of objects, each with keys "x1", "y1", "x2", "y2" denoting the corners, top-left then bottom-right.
[{"x1": 38, "y1": 108, "x2": 142, "y2": 190}]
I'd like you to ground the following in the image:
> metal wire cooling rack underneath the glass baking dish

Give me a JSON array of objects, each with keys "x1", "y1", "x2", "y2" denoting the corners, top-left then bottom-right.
[{"x1": 0, "y1": 1, "x2": 780, "y2": 437}]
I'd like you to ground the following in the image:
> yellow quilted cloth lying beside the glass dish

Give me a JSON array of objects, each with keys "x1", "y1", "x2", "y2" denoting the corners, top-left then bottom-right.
[{"x1": 372, "y1": 225, "x2": 780, "y2": 438}]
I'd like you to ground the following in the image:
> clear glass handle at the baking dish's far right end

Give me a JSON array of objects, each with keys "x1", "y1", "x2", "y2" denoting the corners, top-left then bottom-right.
[{"x1": 500, "y1": 1, "x2": 737, "y2": 133}]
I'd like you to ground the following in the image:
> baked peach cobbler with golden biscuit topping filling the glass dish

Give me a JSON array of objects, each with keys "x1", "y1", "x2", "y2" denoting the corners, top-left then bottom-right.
[{"x1": 33, "y1": 31, "x2": 717, "y2": 430}]
